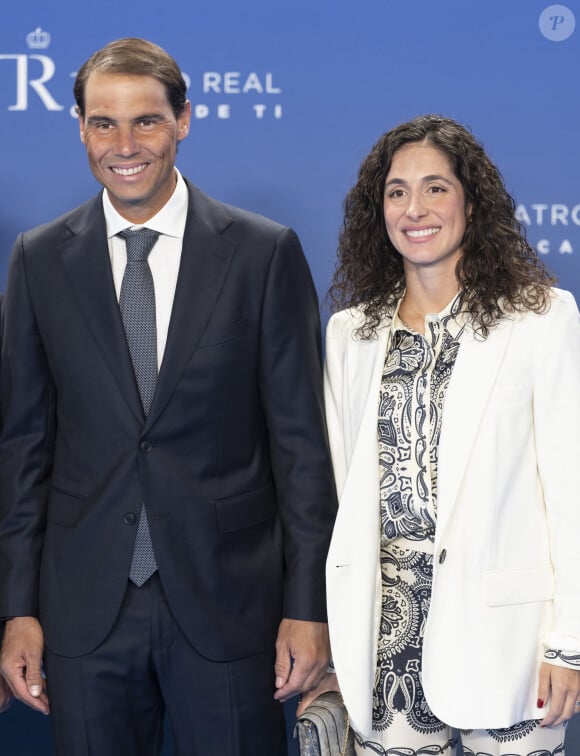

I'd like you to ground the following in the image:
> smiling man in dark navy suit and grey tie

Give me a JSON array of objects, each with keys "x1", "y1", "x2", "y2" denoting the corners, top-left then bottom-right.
[{"x1": 0, "y1": 39, "x2": 336, "y2": 756}]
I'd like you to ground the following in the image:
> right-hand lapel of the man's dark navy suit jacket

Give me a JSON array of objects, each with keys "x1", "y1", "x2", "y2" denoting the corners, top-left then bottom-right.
[{"x1": 147, "y1": 182, "x2": 237, "y2": 425}]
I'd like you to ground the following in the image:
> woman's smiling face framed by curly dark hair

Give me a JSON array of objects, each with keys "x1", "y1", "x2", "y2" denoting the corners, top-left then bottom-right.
[{"x1": 383, "y1": 142, "x2": 470, "y2": 275}]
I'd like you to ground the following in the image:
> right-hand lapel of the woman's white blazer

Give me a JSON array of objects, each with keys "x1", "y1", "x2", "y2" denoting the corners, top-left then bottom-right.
[{"x1": 436, "y1": 318, "x2": 513, "y2": 546}]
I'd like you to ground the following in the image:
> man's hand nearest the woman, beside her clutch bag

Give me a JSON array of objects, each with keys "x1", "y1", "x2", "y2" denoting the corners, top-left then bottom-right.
[{"x1": 274, "y1": 619, "x2": 330, "y2": 701}]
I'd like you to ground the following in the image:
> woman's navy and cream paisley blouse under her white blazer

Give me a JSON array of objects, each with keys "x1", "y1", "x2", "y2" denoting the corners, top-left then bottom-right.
[{"x1": 378, "y1": 296, "x2": 465, "y2": 542}]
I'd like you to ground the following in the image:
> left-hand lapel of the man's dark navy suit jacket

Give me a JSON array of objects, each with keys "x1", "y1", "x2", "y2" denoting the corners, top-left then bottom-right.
[{"x1": 60, "y1": 194, "x2": 144, "y2": 422}]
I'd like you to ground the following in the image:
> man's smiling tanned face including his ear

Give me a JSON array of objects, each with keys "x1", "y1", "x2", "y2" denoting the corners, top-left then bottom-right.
[{"x1": 79, "y1": 71, "x2": 191, "y2": 223}]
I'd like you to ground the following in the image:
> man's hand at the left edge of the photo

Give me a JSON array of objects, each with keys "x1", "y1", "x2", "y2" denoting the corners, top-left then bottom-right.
[{"x1": 0, "y1": 617, "x2": 49, "y2": 714}]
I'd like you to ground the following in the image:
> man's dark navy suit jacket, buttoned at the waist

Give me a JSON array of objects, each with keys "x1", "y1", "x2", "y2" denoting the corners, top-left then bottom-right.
[{"x1": 0, "y1": 183, "x2": 336, "y2": 660}]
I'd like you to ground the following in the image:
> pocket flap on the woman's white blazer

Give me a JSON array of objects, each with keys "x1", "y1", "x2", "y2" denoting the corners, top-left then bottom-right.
[{"x1": 484, "y1": 565, "x2": 554, "y2": 606}]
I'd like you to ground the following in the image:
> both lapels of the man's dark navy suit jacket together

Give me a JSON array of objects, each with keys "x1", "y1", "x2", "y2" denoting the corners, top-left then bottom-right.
[{"x1": 61, "y1": 183, "x2": 237, "y2": 426}]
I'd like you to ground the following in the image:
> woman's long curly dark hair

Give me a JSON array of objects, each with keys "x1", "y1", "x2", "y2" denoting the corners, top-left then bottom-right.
[{"x1": 329, "y1": 115, "x2": 556, "y2": 339}]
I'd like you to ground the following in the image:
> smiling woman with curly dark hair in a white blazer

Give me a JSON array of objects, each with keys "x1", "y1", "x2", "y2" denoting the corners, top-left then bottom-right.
[{"x1": 314, "y1": 116, "x2": 580, "y2": 756}]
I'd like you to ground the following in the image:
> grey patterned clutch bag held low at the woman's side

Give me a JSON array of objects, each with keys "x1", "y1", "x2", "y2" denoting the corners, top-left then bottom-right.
[{"x1": 294, "y1": 691, "x2": 354, "y2": 756}]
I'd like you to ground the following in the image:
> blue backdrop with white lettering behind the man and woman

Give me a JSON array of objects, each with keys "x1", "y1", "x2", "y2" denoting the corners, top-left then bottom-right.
[{"x1": 0, "y1": 0, "x2": 580, "y2": 756}]
